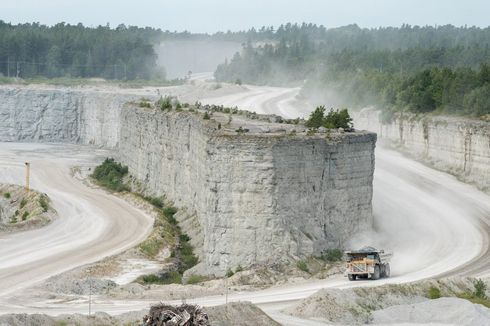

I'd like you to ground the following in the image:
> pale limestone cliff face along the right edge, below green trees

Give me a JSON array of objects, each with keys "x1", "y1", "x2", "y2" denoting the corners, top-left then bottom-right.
[{"x1": 356, "y1": 109, "x2": 490, "y2": 191}]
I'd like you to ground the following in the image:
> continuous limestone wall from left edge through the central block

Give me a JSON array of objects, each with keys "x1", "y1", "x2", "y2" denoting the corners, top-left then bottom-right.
[{"x1": 0, "y1": 88, "x2": 376, "y2": 275}]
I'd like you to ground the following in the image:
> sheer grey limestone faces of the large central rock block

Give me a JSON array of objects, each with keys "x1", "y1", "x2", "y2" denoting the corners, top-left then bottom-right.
[{"x1": 120, "y1": 106, "x2": 376, "y2": 275}]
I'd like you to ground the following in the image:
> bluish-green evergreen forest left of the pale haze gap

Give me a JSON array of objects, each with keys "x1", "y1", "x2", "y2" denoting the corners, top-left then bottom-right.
[{"x1": 0, "y1": 21, "x2": 165, "y2": 80}]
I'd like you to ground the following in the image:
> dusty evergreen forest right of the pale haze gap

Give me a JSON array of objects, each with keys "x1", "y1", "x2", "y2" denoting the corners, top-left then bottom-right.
[{"x1": 215, "y1": 24, "x2": 490, "y2": 116}]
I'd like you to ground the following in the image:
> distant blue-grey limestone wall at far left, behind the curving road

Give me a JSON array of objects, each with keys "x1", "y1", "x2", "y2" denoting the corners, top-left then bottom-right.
[{"x1": 0, "y1": 87, "x2": 142, "y2": 148}]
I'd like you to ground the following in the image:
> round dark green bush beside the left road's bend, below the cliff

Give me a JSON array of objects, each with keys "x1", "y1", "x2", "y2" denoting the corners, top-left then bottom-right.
[{"x1": 92, "y1": 158, "x2": 129, "y2": 192}]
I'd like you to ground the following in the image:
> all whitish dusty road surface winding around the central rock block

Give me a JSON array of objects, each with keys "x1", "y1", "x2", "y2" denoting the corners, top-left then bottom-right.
[{"x1": 0, "y1": 77, "x2": 490, "y2": 325}]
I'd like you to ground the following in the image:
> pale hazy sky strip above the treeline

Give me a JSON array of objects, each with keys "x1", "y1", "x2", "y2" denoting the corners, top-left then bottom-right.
[{"x1": 0, "y1": 0, "x2": 490, "y2": 32}]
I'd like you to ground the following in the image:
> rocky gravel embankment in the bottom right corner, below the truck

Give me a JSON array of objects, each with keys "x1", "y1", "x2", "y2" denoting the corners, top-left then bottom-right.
[{"x1": 284, "y1": 278, "x2": 490, "y2": 326}]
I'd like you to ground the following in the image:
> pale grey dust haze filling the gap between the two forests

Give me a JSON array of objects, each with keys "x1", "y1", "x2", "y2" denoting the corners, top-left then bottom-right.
[{"x1": 155, "y1": 40, "x2": 242, "y2": 79}]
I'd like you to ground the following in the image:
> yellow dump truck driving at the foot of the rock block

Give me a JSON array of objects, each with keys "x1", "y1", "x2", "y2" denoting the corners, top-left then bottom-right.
[{"x1": 344, "y1": 247, "x2": 392, "y2": 281}]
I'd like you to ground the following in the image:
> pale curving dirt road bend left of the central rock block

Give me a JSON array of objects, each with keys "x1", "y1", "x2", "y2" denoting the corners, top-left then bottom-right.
[{"x1": 0, "y1": 143, "x2": 153, "y2": 297}]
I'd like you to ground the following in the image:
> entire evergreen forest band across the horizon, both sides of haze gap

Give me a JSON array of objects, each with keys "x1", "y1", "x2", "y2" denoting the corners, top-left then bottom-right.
[{"x1": 0, "y1": 21, "x2": 490, "y2": 115}]
